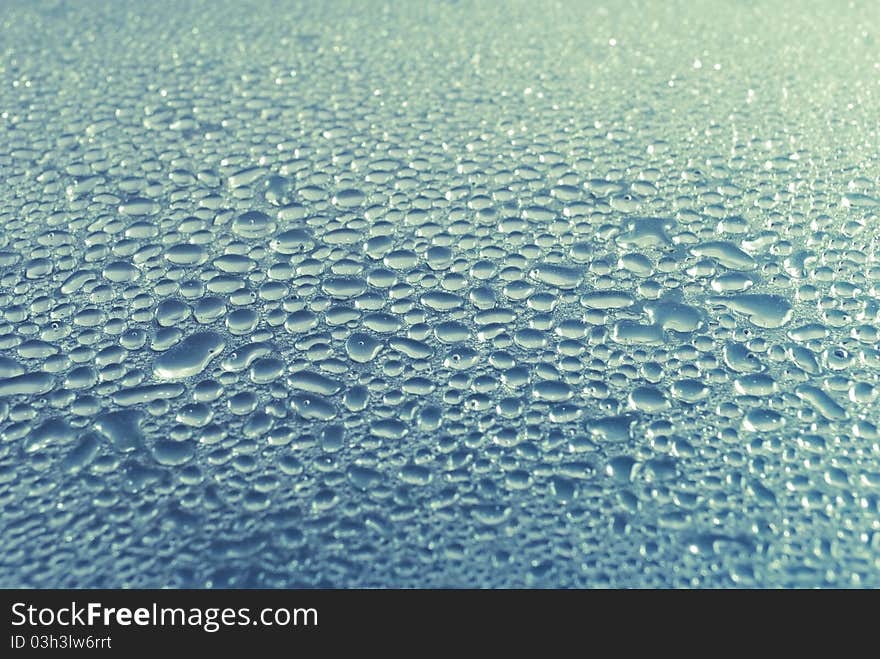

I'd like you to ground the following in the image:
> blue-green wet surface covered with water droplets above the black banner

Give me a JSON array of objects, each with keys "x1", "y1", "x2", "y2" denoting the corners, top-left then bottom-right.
[{"x1": 0, "y1": 2, "x2": 880, "y2": 587}]
